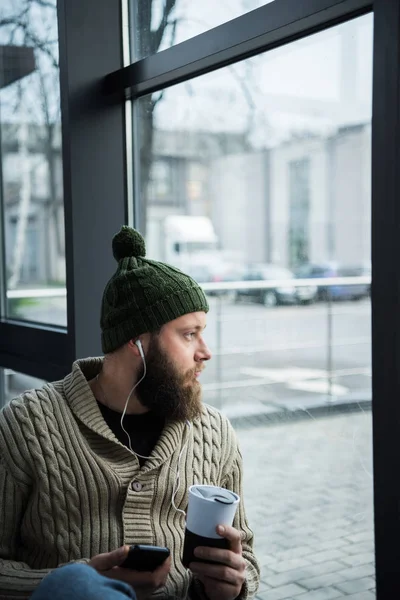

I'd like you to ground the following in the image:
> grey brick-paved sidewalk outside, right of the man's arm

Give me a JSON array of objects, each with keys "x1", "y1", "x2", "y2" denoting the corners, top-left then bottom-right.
[{"x1": 241, "y1": 410, "x2": 375, "y2": 600}]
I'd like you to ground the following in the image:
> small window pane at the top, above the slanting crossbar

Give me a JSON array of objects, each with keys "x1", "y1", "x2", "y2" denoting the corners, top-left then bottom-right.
[{"x1": 131, "y1": 0, "x2": 274, "y2": 59}]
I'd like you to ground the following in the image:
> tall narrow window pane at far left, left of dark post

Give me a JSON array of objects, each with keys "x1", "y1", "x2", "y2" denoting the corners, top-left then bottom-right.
[{"x1": 0, "y1": 0, "x2": 66, "y2": 325}]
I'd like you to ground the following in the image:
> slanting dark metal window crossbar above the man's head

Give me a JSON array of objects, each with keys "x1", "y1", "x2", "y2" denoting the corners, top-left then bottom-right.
[{"x1": 104, "y1": 0, "x2": 373, "y2": 98}]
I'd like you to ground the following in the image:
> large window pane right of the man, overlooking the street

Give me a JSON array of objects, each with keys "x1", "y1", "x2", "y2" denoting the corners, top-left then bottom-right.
[{"x1": 137, "y1": 15, "x2": 375, "y2": 598}]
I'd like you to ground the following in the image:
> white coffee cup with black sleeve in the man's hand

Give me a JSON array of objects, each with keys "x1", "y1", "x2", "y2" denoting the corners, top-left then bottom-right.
[{"x1": 182, "y1": 485, "x2": 240, "y2": 567}]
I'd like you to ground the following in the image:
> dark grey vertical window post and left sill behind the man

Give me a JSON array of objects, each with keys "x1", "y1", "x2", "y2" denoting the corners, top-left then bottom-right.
[{"x1": 0, "y1": 0, "x2": 127, "y2": 382}]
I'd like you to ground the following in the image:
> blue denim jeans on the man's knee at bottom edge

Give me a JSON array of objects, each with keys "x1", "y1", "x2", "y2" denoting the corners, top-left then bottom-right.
[{"x1": 31, "y1": 563, "x2": 136, "y2": 600}]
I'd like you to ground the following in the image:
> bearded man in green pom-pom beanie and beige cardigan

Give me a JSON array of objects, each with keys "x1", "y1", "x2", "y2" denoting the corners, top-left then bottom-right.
[{"x1": 0, "y1": 227, "x2": 259, "y2": 600}]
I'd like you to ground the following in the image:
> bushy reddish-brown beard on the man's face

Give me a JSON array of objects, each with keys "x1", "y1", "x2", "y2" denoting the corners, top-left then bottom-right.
[{"x1": 136, "y1": 334, "x2": 202, "y2": 421}]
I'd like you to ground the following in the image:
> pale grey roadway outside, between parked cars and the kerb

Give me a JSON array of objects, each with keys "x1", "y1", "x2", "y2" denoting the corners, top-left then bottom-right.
[{"x1": 203, "y1": 298, "x2": 371, "y2": 417}]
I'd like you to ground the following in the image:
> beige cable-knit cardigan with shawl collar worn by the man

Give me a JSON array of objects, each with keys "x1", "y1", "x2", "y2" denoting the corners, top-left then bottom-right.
[{"x1": 0, "y1": 358, "x2": 259, "y2": 599}]
